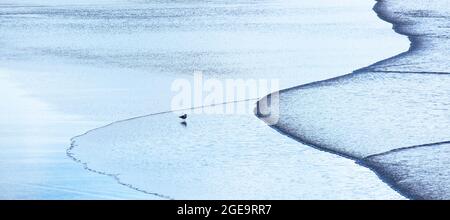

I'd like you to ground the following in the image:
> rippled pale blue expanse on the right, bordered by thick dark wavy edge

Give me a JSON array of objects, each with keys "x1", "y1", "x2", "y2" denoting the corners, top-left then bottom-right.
[{"x1": 260, "y1": 0, "x2": 450, "y2": 199}]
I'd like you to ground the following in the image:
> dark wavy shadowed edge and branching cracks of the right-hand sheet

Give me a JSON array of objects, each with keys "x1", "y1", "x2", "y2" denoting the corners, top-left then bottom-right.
[{"x1": 256, "y1": 0, "x2": 450, "y2": 199}]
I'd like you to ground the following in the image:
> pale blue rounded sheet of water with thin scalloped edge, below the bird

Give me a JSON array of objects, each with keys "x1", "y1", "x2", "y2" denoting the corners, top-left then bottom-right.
[{"x1": 69, "y1": 105, "x2": 402, "y2": 199}]
